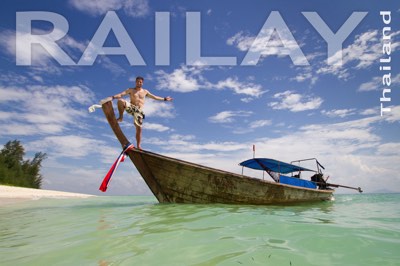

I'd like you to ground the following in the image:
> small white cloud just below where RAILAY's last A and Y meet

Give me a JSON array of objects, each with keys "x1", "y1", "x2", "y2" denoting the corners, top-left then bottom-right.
[{"x1": 268, "y1": 91, "x2": 323, "y2": 112}]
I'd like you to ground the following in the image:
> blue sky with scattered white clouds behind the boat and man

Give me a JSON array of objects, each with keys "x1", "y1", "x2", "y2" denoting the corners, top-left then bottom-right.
[{"x1": 0, "y1": 0, "x2": 400, "y2": 195}]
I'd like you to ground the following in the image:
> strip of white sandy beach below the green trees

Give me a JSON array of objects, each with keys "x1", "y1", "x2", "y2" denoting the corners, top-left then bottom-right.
[{"x1": 0, "y1": 185, "x2": 95, "y2": 205}]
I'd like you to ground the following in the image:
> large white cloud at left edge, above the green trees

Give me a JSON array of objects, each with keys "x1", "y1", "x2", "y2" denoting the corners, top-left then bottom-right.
[{"x1": 0, "y1": 86, "x2": 94, "y2": 136}]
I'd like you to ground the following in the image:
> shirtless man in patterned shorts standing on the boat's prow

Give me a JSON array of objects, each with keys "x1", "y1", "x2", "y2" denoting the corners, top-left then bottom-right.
[{"x1": 112, "y1": 77, "x2": 172, "y2": 149}]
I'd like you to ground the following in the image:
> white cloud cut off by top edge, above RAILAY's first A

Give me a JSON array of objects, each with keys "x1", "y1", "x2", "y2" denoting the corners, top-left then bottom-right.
[{"x1": 69, "y1": 0, "x2": 150, "y2": 18}]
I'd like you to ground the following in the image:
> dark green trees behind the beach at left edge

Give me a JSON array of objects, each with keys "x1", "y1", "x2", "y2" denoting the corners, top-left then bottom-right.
[{"x1": 0, "y1": 140, "x2": 46, "y2": 188}]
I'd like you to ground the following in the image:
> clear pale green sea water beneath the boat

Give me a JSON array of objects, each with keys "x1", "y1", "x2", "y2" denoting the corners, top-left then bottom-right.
[{"x1": 0, "y1": 194, "x2": 400, "y2": 266}]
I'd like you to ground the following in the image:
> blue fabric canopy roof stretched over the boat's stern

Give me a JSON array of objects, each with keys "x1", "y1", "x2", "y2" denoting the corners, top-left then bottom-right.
[{"x1": 239, "y1": 158, "x2": 315, "y2": 174}]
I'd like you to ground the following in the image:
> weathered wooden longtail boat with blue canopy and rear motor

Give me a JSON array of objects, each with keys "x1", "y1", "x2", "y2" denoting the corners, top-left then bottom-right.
[{"x1": 102, "y1": 101, "x2": 361, "y2": 205}]
